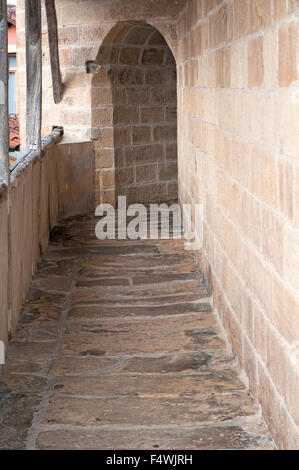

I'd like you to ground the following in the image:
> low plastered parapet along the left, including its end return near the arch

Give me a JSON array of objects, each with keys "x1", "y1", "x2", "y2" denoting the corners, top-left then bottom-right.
[{"x1": 0, "y1": 134, "x2": 94, "y2": 344}]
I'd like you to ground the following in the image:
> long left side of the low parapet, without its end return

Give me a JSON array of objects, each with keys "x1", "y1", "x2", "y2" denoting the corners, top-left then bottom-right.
[{"x1": 0, "y1": 138, "x2": 58, "y2": 344}]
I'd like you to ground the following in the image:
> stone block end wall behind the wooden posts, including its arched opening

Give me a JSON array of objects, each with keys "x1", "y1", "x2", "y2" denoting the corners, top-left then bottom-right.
[{"x1": 17, "y1": 0, "x2": 185, "y2": 203}]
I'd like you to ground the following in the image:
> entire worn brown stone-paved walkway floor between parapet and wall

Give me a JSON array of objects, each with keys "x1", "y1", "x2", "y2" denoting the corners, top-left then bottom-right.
[{"x1": 0, "y1": 210, "x2": 275, "y2": 450}]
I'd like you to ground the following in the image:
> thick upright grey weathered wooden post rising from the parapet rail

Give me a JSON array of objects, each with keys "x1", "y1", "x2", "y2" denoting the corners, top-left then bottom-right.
[{"x1": 25, "y1": 0, "x2": 42, "y2": 150}]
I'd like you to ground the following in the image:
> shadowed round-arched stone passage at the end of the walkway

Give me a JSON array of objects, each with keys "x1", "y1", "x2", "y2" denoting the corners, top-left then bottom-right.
[{"x1": 91, "y1": 22, "x2": 178, "y2": 204}]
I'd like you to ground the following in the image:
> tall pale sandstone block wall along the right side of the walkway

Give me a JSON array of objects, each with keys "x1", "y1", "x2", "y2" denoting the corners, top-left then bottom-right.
[{"x1": 178, "y1": 0, "x2": 299, "y2": 448}]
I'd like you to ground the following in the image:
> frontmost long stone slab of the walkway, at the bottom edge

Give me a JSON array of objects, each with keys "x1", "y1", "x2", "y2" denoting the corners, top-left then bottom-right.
[{"x1": 37, "y1": 423, "x2": 273, "y2": 453}]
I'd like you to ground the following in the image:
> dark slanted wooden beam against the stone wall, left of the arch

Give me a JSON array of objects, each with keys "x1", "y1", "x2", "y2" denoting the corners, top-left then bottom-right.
[{"x1": 45, "y1": 0, "x2": 63, "y2": 104}]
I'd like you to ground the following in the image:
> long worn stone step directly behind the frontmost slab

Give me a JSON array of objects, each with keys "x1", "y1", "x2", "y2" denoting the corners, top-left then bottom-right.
[{"x1": 43, "y1": 392, "x2": 255, "y2": 426}]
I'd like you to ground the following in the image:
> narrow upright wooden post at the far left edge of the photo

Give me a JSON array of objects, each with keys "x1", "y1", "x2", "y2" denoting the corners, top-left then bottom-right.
[{"x1": 0, "y1": 0, "x2": 9, "y2": 185}]
